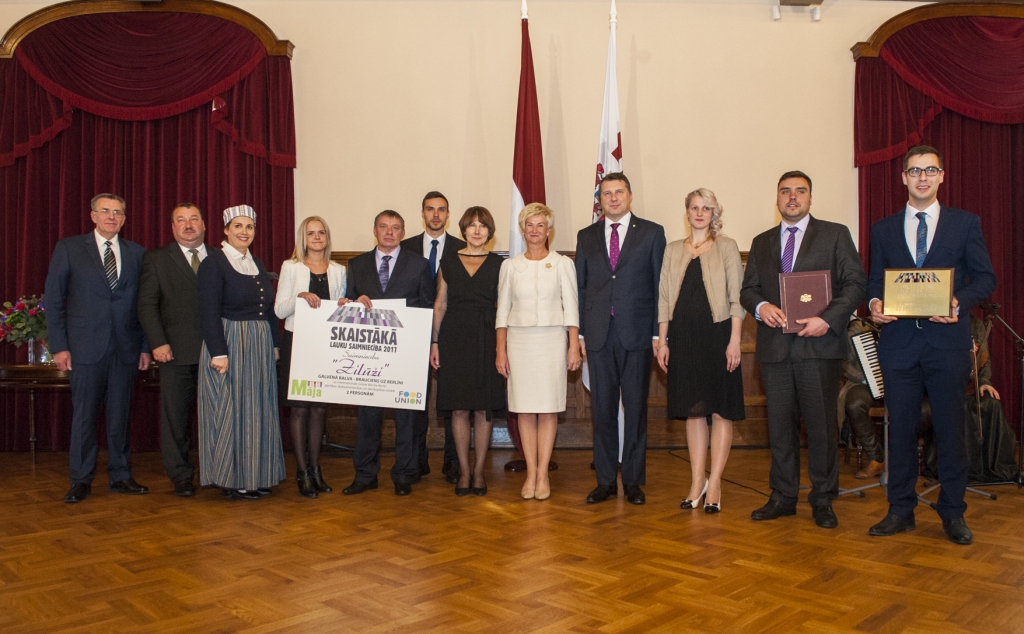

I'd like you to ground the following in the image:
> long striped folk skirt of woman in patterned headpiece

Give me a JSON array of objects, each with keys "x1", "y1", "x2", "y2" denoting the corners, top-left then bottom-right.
[{"x1": 199, "y1": 320, "x2": 285, "y2": 491}]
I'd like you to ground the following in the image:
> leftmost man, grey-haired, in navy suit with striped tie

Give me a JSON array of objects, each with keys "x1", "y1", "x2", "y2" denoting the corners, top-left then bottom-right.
[{"x1": 45, "y1": 194, "x2": 151, "y2": 504}]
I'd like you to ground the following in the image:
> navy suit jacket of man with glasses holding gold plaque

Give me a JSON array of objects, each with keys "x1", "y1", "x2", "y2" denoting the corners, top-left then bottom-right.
[{"x1": 867, "y1": 206, "x2": 995, "y2": 351}]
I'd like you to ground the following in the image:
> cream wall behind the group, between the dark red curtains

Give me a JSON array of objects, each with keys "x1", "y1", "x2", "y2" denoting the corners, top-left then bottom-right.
[{"x1": 0, "y1": 0, "x2": 918, "y2": 251}]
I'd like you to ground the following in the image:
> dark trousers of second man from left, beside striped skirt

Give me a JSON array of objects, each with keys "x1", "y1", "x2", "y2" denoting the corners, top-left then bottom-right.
[{"x1": 160, "y1": 364, "x2": 199, "y2": 484}]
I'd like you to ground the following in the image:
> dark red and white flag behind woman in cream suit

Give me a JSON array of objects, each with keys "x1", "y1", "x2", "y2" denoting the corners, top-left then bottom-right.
[{"x1": 509, "y1": 0, "x2": 545, "y2": 257}]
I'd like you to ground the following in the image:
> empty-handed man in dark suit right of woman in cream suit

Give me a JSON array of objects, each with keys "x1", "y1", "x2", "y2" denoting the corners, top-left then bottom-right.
[{"x1": 575, "y1": 172, "x2": 665, "y2": 504}]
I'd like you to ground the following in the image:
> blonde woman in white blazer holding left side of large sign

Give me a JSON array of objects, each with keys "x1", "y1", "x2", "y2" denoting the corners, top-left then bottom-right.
[{"x1": 273, "y1": 216, "x2": 345, "y2": 498}]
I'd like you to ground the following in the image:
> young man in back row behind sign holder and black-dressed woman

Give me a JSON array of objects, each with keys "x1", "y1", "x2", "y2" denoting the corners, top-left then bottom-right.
[{"x1": 401, "y1": 192, "x2": 466, "y2": 484}]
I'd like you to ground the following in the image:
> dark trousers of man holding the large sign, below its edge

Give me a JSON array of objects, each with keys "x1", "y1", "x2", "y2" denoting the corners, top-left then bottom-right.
[{"x1": 352, "y1": 407, "x2": 419, "y2": 484}]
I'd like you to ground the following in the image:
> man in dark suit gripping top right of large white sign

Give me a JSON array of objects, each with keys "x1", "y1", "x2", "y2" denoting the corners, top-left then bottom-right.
[{"x1": 342, "y1": 209, "x2": 436, "y2": 496}]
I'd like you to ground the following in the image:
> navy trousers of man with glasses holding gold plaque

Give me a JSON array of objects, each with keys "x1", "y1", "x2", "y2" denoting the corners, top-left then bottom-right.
[{"x1": 879, "y1": 331, "x2": 971, "y2": 519}]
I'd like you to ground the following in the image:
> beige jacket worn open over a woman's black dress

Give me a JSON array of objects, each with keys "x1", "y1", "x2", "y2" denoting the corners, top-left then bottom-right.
[{"x1": 657, "y1": 234, "x2": 746, "y2": 324}]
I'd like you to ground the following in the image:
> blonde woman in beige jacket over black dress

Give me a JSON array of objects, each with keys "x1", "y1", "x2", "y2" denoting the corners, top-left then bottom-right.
[{"x1": 657, "y1": 188, "x2": 746, "y2": 513}]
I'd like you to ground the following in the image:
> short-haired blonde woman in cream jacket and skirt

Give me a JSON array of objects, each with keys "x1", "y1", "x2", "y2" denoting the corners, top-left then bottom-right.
[{"x1": 495, "y1": 203, "x2": 581, "y2": 500}]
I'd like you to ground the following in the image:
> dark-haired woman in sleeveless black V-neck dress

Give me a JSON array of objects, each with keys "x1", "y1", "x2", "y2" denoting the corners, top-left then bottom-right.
[{"x1": 430, "y1": 207, "x2": 505, "y2": 496}]
